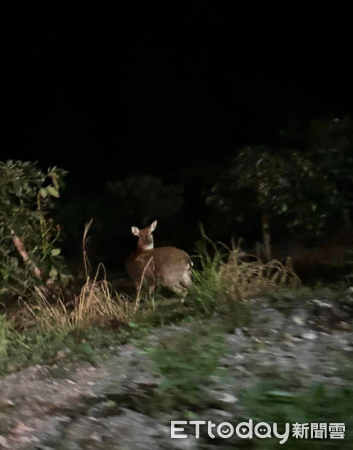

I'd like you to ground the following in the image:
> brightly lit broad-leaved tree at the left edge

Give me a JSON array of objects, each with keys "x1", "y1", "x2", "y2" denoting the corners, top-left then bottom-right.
[{"x1": 0, "y1": 161, "x2": 70, "y2": 297}]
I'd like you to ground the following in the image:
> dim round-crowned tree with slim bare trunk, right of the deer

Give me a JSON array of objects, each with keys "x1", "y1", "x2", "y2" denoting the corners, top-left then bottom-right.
[{"x1": 207, "y1": 146, "x2": 337, "y2": 259}]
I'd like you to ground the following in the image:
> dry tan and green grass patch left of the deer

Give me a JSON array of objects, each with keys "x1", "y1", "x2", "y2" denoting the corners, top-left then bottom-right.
[{"x1": 0, "y1": 270, "x2": 153, "y2": 376}]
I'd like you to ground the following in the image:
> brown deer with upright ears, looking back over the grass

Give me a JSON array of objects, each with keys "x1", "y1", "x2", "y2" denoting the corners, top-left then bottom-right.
[{"x1": 126, "y1": 220, "x2": 193, "y2": 302}]
